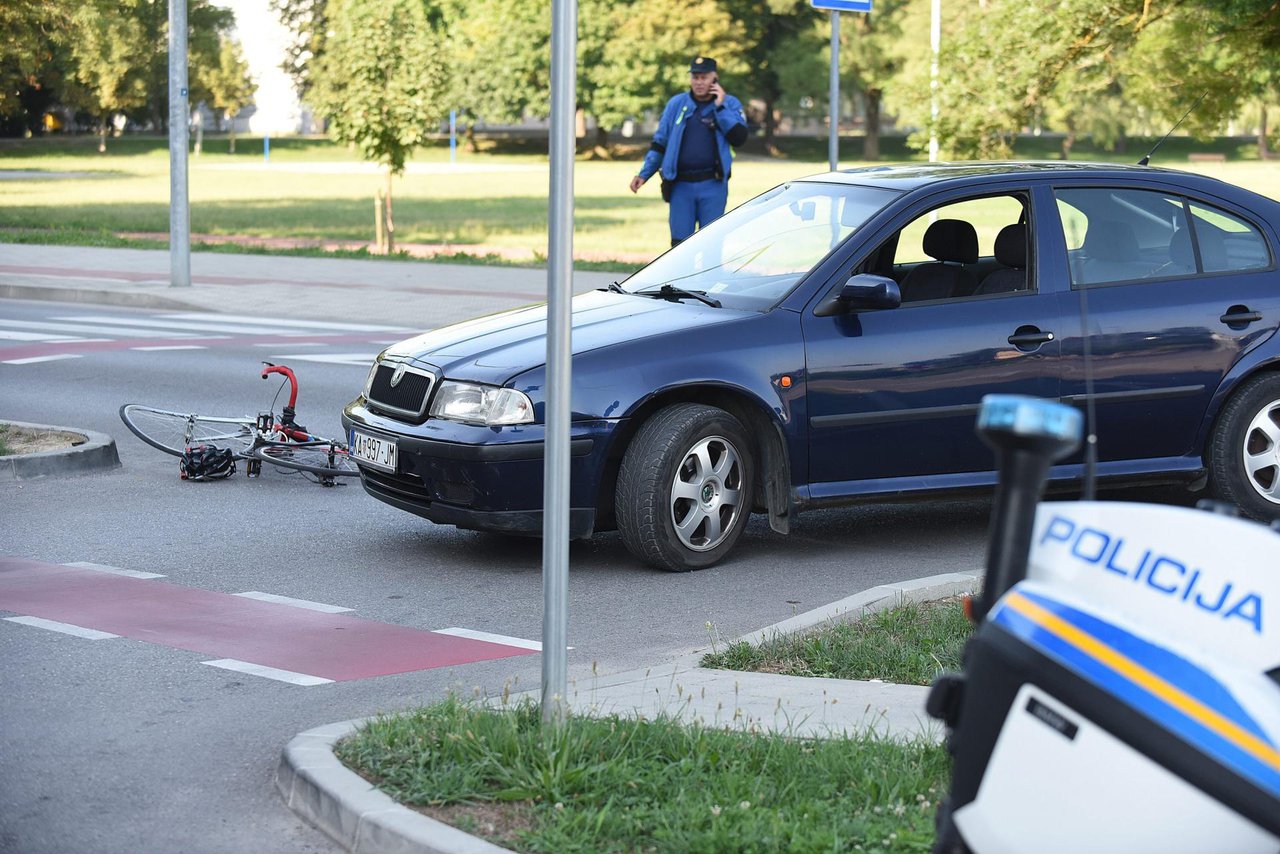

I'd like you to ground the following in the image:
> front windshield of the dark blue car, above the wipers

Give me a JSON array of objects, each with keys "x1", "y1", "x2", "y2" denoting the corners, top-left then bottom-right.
[{"x1": 623, "y1": 182, "x2": 900, "y2": 309}]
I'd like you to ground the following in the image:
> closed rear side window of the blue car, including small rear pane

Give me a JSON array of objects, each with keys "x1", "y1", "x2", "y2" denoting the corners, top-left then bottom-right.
[{"x1": 1057, "y1": 188, "x2": 1271, "y2": 284}]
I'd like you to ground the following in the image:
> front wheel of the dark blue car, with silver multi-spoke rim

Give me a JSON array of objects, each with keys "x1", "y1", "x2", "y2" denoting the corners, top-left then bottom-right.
[{"x1": 614, "y1": 403, "x2": 755, "y2": 572}]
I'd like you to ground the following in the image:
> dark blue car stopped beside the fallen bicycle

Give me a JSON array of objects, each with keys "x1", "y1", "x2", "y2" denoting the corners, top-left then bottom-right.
[{"x1": 343, "y1": 163, "x2": 1280, "y2": 570}]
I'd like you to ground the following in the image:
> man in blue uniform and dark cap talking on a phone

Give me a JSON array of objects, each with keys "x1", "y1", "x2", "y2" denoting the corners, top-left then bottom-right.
[{"x1": 631, "y1": 56, "x2": 746, "y2": 246}]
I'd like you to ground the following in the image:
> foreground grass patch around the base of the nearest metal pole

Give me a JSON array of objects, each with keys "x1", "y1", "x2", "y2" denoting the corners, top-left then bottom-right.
[{"x1": 338, "y1": 699, "x2": 950, "y2": 854}]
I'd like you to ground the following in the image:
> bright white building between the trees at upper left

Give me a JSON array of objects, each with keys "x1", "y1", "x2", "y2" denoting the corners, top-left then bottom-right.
[{"x1": 214, "y1": 0, "x2": 312, "y2": 136}]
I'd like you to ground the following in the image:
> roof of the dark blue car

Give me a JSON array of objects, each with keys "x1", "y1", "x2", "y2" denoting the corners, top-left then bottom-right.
[{"x1": 801, "y1": 160, "x2": 1203, "y2": 192}]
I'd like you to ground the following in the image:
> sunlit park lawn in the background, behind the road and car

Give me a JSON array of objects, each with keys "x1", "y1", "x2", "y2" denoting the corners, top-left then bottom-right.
[{"x1": 0, "y1": 136, "x2": 1280, "y2": 263}]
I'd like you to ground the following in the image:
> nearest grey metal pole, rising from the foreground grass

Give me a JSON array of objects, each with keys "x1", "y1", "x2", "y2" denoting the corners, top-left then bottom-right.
[{"x1": 543, "y1": 0, "x2": 577, "y2": 725}]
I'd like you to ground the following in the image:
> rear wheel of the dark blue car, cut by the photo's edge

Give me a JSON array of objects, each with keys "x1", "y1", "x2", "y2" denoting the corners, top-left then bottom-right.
[{"x1": 1208, "y1": 374, "x2": 1280, "y2": 521}]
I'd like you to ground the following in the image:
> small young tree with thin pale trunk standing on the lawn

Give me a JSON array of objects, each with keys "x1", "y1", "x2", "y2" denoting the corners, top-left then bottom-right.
[{"x1": 311, "y1": 0, "x2": 448, "y2": 252}]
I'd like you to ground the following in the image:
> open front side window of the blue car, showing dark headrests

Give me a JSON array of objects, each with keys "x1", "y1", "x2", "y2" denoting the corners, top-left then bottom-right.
[{"x1": 861, "y1": 193, "x2": 1036, "y2": 302}]
